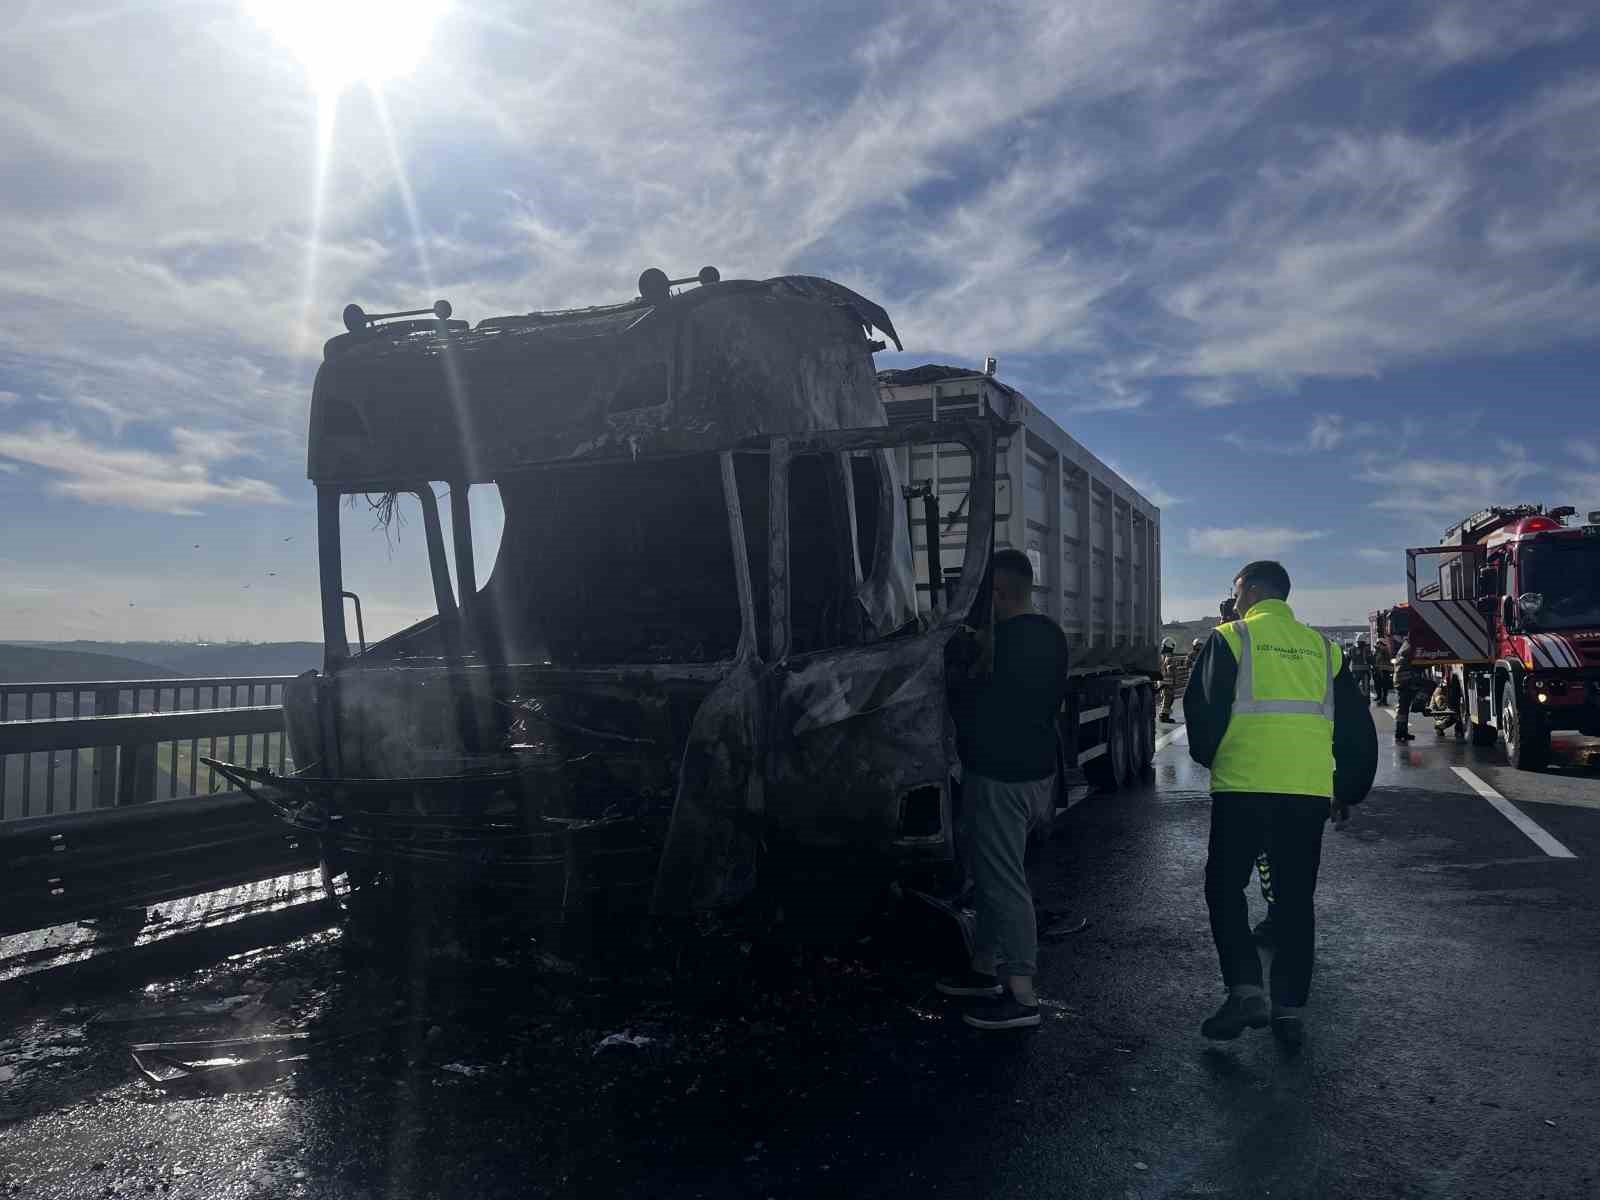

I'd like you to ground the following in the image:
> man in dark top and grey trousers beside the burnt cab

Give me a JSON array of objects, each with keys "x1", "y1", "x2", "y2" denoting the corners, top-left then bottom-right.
[{"x1": 936, "y1": 550, "x2": 1069, "y2": 1029}]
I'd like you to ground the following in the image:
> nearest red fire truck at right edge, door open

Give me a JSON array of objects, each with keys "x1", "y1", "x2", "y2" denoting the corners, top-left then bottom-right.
[{"x1": 1406, "y1": 504, "x2": 1600, "y2": 771}]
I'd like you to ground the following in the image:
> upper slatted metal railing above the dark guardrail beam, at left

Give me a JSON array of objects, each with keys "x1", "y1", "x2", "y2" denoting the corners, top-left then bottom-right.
[{"x1": 0, "y1": 675, "x2": 293, "y2": 821}]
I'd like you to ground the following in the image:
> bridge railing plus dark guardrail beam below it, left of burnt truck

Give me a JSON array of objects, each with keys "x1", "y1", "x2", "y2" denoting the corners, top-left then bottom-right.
[{"x1": 0, "y1": 675, "x2": 318, "y2": 934}]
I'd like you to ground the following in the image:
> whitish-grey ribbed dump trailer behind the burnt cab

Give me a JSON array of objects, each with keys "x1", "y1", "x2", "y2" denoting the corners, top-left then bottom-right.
[{"x1": 878, "y1": 365, "x2": 1162, "y2": 797}]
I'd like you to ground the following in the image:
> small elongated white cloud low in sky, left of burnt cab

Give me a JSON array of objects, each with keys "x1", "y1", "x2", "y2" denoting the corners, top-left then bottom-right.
[{"x1": 0, "y1": 426, "x2": 288, "y2": 515}]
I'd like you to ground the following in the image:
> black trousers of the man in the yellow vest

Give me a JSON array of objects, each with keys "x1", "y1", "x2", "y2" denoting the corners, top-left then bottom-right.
[{"x1": 1205, "y1": 792, "x2": 1328, "y2": 1008}]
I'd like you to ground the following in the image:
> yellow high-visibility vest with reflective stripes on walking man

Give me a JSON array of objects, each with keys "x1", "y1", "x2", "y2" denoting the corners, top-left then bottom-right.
[{"x1": 1211, "y1": 600, "x2": 1344, "y2": 797}]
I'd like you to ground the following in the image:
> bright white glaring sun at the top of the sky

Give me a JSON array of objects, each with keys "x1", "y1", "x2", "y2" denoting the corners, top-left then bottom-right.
[{"x1": 245, "y1": 0, "x2": 448, "y2": 94}]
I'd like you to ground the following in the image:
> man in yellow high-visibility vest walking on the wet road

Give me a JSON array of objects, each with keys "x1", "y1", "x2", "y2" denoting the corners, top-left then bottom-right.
[{"x1": 1184, "y1": 562, "x2": 1378, "y2": 1048}]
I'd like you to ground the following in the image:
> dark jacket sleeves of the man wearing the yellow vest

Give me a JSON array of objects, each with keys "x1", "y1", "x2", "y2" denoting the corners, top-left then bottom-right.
[{"x1": 1184, "y1": 637, "x2": 1378, "y2": 805}]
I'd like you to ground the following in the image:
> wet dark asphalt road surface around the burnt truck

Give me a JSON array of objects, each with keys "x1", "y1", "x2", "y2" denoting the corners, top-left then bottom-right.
[{"x1": 0, "y1": 714, "x2": 1600, "y2": 1200}]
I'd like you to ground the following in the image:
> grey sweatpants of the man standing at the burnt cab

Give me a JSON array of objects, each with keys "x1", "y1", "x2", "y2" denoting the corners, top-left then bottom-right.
[{"x1": 960, "y1": 771, "x2": 1056, "y2": 976}]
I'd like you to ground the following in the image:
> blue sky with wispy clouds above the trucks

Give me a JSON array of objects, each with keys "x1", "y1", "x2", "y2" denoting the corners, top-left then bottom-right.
[{"x1": 0, "y1": 0, "x2": 1600, "y2": 640}]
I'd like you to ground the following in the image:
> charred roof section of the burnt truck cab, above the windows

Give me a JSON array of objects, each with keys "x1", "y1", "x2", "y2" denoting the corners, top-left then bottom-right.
[{"x1": 307, "y1": 275, "x2": 899, "y2": 491}]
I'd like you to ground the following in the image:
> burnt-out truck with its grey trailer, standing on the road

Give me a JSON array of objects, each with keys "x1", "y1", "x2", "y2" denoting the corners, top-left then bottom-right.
[{"x1": 216, "y1": 275, "x2": 1158, "y2": 936}]
